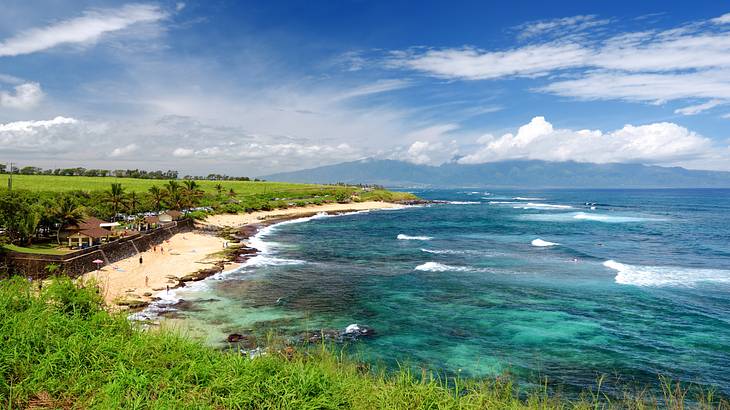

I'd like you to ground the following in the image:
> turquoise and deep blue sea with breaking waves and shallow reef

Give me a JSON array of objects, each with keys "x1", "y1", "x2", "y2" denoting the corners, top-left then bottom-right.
[{"x1": 151, "y1": 190, "x2": 730, "y2": 395}]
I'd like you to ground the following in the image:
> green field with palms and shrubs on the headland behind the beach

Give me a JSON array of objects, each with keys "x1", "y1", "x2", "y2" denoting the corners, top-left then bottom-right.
[{"x1": 0, "y1": 175, "x2": 415, "y2": 254}]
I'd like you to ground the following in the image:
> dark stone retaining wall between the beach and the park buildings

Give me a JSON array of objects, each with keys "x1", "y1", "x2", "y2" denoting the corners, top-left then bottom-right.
[{"x1": 6, "y1": 220, "x2": 193, "y2": 279}]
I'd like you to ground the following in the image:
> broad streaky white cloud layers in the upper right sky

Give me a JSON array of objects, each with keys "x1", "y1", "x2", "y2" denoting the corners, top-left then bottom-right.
[{"x1": 387, "y1": 14, "x2": 730, "y2": 109}]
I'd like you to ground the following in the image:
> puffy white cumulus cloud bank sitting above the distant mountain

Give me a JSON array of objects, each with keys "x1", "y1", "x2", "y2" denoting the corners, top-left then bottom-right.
[{"x1": 458, "y1": 117, "x2": 716, "y2": 165}]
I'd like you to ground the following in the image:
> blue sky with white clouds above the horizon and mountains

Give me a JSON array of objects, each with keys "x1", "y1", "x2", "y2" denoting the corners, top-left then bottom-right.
[{"x1": 0, "y1": 0, "x2": 730, "y2": 175}]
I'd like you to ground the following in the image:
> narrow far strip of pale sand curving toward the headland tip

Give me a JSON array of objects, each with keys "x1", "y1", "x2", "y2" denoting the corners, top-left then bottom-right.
[{"x1": 203, "y1": 201, "x2": 403, "y2": 228}]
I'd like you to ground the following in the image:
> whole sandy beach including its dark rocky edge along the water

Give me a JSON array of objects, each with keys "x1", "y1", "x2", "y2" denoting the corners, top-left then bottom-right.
[{"x1": 82, "y1": 201, "x2": 405, "y2": 310}]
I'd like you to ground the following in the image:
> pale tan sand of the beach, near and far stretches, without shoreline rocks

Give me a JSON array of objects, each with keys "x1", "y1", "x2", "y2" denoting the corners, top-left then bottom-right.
[{"x1": 83, "y1": 201, "x2": 403, "y2": 305}]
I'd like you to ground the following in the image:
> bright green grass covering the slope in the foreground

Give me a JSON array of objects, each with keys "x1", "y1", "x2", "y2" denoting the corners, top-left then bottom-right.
[{"x1": 0, "y1": 278, "x2": 727, "y2": 409}]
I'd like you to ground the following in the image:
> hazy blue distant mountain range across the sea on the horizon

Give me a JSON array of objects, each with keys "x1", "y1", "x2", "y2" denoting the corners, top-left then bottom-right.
[{"x1": 263, "y1": 159, "x2": 730, "y2": 188}]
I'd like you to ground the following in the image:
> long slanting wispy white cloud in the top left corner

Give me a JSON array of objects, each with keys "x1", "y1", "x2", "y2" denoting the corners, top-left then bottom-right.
[{"x1": 0, "y1": 4, "x2": 166, "y2": 57}]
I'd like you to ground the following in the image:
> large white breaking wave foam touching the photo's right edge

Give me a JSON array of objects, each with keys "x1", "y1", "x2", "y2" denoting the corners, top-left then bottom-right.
[{"x1": 603, "y1": 260, "x2": 730, "y2": 287}]
